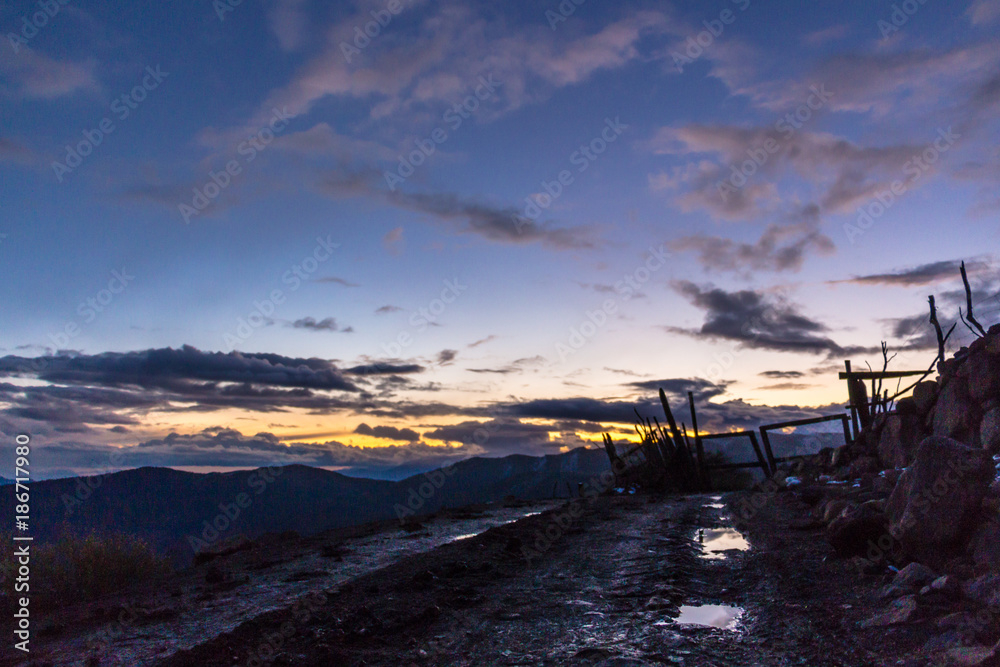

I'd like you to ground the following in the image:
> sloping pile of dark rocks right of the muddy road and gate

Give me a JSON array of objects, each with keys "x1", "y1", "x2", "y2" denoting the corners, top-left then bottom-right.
[{"x1": 780, "y1": 325, "x2": 1000, "y2": 665}]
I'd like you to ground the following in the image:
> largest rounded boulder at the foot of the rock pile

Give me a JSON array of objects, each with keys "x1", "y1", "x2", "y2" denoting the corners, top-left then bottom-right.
[{"x1": 886, "y1": 436, "x2": 995, "y2": 561}]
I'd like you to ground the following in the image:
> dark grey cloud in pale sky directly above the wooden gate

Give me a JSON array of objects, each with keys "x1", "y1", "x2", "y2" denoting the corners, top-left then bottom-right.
[{"x1": 665, "y1": 281, "x2": 866, "y2": 355}]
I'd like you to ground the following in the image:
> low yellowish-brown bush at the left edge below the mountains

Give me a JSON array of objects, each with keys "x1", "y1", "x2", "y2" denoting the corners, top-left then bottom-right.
[{"x1": 0, "y1": 533, "x2": 170, "y2": 606}]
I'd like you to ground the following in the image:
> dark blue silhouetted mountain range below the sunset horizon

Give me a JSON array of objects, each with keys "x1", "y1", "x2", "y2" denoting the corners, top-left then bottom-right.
[{"x1": 0, "y1": 448, "x2": 609, "y2": 562}]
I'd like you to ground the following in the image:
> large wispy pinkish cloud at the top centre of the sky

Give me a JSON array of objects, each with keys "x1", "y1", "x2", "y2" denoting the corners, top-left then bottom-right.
[{"x1": 251, "y1": 2, "x2": 669, "y2": 125}]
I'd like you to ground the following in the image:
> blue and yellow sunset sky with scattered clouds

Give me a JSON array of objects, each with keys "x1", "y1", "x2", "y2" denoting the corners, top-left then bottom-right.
[{"x1": 0, "y1": 0, "x2": 1000, "y2": 478}]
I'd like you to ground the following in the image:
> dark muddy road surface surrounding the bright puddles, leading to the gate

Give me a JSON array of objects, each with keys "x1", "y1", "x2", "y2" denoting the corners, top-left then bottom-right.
[{"x1": 129, "y1": 490, "x2": 932, "y2": 667}]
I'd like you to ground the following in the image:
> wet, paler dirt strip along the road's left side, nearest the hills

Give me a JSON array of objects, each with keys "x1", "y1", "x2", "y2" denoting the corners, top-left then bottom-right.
[{"x1": 0, "y1": 501, "x2": 561, "y2": 667}]
